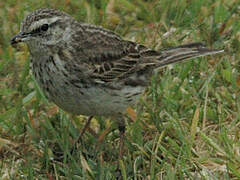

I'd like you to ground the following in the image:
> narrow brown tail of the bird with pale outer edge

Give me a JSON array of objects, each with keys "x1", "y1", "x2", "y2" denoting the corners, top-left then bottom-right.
[{"x1": 155, "y1": 43, "x2": 224, "y2": 67}]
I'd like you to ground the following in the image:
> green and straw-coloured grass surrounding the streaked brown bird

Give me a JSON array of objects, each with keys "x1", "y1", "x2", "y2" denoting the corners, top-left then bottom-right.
[{"x1": 0, "y1": 0, "x2": 240, "y2": 180}]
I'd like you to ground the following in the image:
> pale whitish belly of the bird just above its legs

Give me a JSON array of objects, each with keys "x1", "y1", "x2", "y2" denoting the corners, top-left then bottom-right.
[{"x1": 39, "y1": 79, "x2": 144, "y2": 116}]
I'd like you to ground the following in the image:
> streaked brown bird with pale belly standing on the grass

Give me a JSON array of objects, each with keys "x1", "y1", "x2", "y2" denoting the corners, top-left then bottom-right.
[{"x1": 10, "y1": 8, "x2": 223, "y2": 157}]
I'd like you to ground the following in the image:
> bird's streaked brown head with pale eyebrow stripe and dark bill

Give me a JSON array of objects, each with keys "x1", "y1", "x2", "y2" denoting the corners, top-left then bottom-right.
[{"x1": 11, "y1": 9, "x2": 73, "y2": 46}]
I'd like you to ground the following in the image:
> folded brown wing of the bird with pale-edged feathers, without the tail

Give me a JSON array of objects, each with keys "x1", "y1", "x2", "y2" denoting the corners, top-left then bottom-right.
[{"x1": 72, "y1": 25, "x2": 158, "y2": 82}]
